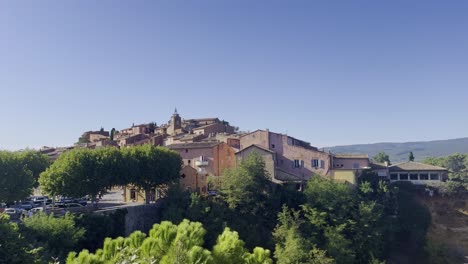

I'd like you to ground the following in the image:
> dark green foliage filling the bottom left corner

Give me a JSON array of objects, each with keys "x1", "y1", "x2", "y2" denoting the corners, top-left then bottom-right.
[{"x1": 0, "y1": 214, "x2": 36, "y2": 264}]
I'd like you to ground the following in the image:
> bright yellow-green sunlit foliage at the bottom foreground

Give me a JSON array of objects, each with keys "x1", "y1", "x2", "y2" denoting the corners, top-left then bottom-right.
[{"x1": 67, "y1": 220, "x2": 272, "y2": 264}]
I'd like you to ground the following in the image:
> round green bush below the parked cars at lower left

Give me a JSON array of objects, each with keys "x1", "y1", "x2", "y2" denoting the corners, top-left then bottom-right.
[{"x1": 21, "y1": 213, "x2": 85, "y2": 260}]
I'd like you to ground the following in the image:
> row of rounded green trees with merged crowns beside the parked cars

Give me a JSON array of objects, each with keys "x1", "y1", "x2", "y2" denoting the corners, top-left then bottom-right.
[{"x1": 39, "y1": 145, "x2": 182, "y2": 203}]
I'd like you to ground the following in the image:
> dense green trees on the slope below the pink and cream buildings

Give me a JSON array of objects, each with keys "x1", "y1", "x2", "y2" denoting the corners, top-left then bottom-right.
[{"x1": 274, "y1": 174, "x2": 394, "y2": 263}]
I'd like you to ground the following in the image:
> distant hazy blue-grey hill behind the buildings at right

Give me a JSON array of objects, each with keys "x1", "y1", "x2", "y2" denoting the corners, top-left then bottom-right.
[{"x1": 325, "y1": 138, "x2": 468, "y2": 163}]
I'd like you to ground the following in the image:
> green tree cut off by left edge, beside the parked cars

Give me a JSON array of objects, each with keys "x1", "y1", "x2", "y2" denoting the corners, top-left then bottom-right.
[{"x1": 0, "y1": 151, "x2": 34, "y2": 203}]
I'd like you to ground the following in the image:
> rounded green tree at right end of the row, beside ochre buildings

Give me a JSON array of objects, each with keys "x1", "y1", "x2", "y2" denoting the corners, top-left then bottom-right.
[{"x1": 122, "y1": 145, "x2": 182, "y2": 203}]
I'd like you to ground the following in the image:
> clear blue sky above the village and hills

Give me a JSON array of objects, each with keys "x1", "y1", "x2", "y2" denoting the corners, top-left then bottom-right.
[{"x1": 0, "y1": 0, "x2": 468, "y2": 149}]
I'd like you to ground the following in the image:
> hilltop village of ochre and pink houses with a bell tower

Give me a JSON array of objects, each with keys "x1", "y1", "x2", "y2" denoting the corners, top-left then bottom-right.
[{"x1": 41, "y1": 109, "x2": 448, "y2": 201}]
